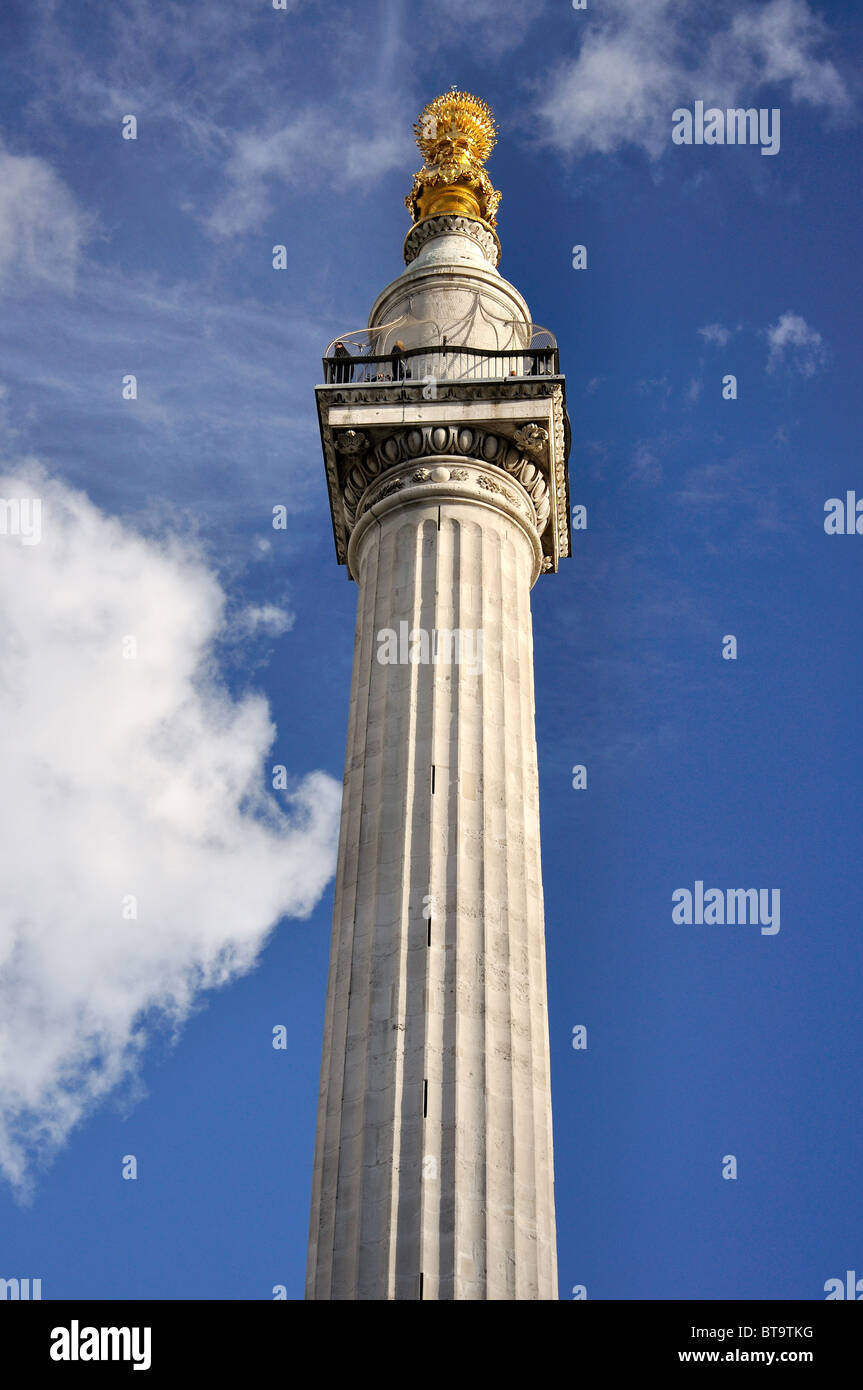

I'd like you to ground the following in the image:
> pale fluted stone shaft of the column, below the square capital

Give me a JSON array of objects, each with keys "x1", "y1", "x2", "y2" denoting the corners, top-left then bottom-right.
[{"x1": 307, "y1": 459, "x2": 557, "y2": 1300}]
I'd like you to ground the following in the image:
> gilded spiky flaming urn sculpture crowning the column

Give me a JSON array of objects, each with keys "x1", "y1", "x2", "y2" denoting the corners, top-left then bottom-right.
[{"x1": 404, "y1": 89, "x2": 500, "y2": 227}]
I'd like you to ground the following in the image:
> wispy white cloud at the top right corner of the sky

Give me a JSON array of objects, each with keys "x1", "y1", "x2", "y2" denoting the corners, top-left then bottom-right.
[{"x1": 538, "y1": 0, "x2": 852, "y2": 158}]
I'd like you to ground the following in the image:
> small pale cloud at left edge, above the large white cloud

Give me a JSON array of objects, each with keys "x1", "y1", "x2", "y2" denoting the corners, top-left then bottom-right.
[{"x1": 0, "y1": 140, "x2": 92, "y2": 291}]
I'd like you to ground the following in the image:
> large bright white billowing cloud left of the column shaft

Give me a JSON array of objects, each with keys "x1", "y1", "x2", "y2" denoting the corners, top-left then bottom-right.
[{"x1": 0, "y1": 464, "x2": 340, "y2": 1193}]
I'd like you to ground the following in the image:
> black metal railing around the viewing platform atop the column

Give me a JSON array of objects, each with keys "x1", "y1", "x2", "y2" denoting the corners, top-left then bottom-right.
[{"x1": 324, "y1": 345, "x2": 559, "y2": 386}]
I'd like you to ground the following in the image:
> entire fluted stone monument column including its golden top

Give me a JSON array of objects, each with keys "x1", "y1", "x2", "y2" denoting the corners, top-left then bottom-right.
[{"x1": 306, "y1": 92, "x2": 570, "y2": 1300}]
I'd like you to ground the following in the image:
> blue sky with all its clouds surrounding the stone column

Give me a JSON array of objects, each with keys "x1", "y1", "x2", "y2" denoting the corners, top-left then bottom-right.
[{"x1": 0, "y1": 0, "x2": 863, "y2": 1300}]
